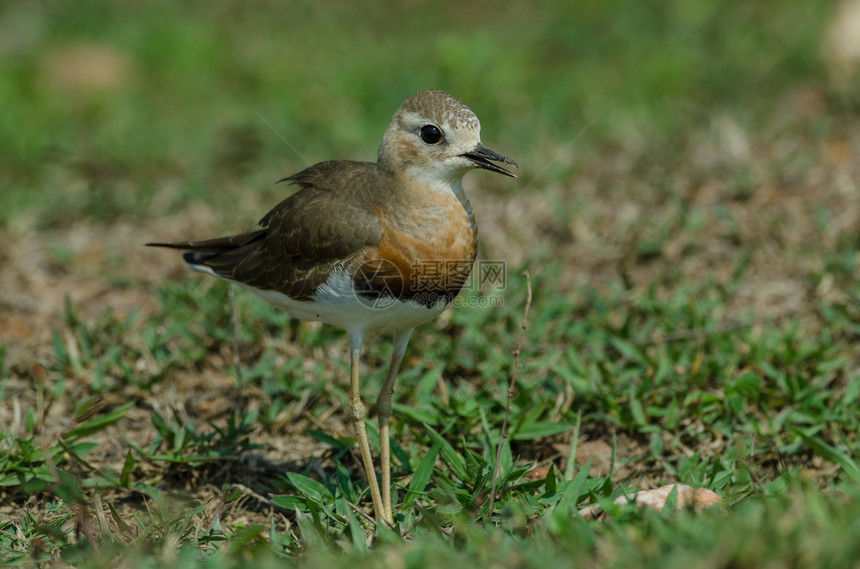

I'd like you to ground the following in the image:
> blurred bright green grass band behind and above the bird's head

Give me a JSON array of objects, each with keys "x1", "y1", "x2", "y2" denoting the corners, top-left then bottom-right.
[{"x1": 0, "y1": 1, "x2": 829, "y2": 224}]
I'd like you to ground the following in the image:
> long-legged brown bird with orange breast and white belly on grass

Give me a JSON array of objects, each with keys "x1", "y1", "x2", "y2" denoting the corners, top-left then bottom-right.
[{"x1": 146, "y1": 90, "x2": 519, "y2": 527}]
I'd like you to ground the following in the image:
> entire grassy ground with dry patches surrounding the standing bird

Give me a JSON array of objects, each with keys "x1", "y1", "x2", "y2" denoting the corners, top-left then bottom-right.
[{"x1": 0, "y1": 0, "x2": 860, "y2": 568}]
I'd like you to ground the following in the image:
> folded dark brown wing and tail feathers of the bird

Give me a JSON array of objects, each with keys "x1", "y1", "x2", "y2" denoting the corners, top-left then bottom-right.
[{"x1": 149, "y1": 161, "x2": 382, "y2": 300}]
